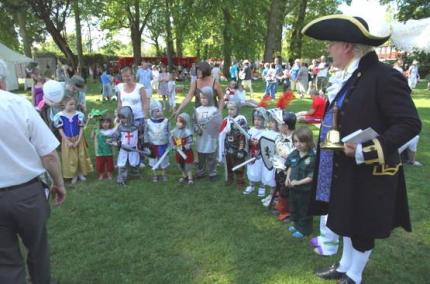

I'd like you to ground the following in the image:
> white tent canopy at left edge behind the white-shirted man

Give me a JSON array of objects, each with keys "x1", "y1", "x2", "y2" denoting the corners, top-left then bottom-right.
[{"x1": 0, "y1": 43, "x2": 33, "y2": 91}]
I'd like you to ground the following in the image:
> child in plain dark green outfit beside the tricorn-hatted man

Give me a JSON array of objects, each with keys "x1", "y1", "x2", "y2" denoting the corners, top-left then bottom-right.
[{"x1": 285, "y1": 126, "x2": 315, "y2": 238}]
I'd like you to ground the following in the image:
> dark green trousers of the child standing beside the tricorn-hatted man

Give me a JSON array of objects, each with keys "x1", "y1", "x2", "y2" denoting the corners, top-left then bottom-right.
[{"x1": 289, "y1": 188, "x2": 312, "y2": 235}]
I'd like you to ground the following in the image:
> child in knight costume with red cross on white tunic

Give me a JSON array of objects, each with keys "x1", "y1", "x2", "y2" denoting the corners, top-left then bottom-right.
[{"x1": 113, "y1": 106, "x2": 140, "y2": 185}]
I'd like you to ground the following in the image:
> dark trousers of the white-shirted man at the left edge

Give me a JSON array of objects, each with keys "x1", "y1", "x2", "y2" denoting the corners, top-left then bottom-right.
[{"x1": 0, "y1": 181, "x2": 50, "y2": 284}]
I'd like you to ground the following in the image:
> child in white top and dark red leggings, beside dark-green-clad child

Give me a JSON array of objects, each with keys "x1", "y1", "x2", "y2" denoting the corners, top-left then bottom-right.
[{"x1": 263, "y1": 109, "x2": 297, "y2": 221}]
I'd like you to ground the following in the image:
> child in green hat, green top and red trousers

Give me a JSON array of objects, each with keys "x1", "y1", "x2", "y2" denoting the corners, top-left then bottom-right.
[{"x1": 91, "y1": 115, "x2": 115, "y2": 180}]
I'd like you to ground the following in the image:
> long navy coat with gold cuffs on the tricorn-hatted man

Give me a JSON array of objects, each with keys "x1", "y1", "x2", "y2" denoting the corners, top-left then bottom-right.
[{"x1": 310, "y1": 52, "x2": 421, "y2": 238}]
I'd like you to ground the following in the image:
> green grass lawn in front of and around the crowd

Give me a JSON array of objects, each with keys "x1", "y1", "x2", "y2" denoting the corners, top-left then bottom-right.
[{"x1": 44, "y1": 79, "x2": 430, "y2": 283}]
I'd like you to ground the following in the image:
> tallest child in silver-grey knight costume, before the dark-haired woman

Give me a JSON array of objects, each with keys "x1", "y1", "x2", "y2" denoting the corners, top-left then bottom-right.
[{"x1": 193, "y1": 90, "x2": 222, "y2": 180}]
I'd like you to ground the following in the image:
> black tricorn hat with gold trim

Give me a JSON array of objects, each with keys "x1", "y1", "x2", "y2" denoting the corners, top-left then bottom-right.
[{"x1": 302, "y1": 15, "x2": 390, "y2": 46}]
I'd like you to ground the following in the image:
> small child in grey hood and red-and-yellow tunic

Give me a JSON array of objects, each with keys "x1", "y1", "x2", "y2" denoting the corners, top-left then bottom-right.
[{"x1": 170, "y1": 112, "x2": 194, "y2": 184}]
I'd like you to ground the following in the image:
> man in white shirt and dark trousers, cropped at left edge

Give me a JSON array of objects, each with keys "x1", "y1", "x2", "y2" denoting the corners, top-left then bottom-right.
[{"x1": 0, "y1": 60, "x2": 66, "y2": 284}]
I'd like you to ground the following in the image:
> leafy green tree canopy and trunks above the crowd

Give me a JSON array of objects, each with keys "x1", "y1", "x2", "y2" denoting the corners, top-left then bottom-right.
[{"x1": 9, "y1": 0, "x2": 424, "y2": 66}]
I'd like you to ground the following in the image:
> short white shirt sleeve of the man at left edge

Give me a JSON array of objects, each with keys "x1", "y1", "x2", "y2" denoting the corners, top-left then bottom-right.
[{"x1": 24, "y1": 102, "x2": 60, "y2": 157}]
